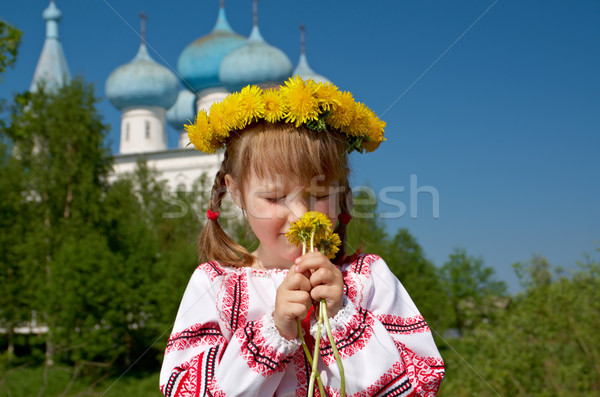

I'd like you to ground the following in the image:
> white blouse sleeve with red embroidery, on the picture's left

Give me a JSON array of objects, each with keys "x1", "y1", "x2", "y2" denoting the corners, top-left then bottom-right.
[{"x1": 160, "y1": 267, "x2": 300, "y2": 397}]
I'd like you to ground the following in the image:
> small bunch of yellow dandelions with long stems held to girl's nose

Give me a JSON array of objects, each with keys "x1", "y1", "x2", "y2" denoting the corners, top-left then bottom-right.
[{"x1": 286, "y1": 211, "x2": 346, "y2": 397}]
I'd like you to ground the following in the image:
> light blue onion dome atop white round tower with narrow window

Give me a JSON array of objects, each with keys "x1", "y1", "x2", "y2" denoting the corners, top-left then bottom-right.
[{"x1": 105, "y1": 43, "x2": 179, "y2": 110}]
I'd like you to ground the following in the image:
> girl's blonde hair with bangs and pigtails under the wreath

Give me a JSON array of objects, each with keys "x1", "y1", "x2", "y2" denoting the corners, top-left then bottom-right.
[{"x1": 198, "y1": 122, "x2": 352, "y2": 266}]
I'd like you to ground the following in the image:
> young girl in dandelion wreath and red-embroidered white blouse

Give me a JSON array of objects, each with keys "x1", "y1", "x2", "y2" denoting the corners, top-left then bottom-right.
[{"x1": 160, "y1": 77, "x2": 444, "y2": 396}]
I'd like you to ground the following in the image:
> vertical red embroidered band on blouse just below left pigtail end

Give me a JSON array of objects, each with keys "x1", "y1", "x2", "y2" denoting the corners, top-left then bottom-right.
[{"x1": 219, "y1": 272, "x2": 249, "y2": 332}]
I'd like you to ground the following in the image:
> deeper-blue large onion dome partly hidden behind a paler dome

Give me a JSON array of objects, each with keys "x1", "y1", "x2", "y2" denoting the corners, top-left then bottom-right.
[{"x1": 177, "y1": 1, "x2": 246, "y2": 92}]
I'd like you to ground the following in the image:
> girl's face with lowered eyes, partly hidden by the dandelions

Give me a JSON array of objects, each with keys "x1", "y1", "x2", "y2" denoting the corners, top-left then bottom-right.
[{"x1": 225, "y1": 172, "x2": 340, "y2": 269}]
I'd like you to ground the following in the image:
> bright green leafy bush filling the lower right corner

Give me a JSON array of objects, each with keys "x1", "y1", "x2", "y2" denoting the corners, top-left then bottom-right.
[{"x1": 440, "y1": 254, "x2": 600, "y2": 396}]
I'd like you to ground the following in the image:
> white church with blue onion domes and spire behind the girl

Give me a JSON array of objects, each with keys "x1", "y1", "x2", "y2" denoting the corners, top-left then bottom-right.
[{"x1": 30, "y1": 0, "x2": 328, "y2": 190}]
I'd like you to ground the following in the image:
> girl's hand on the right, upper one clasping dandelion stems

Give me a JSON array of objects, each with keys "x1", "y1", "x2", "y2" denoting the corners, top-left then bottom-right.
[{"x1": 292, "y1": 251, "x2": 344, "y2": 317}]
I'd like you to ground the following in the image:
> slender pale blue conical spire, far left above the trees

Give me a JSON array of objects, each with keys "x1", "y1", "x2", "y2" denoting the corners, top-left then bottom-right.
[{"x1": 29, "y1": 0, "x2": 71, "y2": 92}]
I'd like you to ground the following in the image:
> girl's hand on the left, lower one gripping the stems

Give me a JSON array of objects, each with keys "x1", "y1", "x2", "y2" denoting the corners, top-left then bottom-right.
[{"x1": 273, "y1": 266, "x2": 312, "y2": 340}]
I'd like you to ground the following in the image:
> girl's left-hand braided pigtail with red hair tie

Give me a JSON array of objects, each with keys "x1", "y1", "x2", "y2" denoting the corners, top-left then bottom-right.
[{"x1": 198, "y1": 151, "x2": 254, "y2": 266}]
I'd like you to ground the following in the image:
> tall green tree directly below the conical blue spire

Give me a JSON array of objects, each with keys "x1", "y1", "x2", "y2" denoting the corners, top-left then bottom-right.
[{"x1": 3, "y1": 79, "x2": 111, "y2": 363}]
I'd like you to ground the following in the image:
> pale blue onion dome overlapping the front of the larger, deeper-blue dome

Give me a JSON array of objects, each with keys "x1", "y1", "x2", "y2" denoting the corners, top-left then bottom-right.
[{"x1": 219, "y1": 0, "x2": 293, "y2": 91}]
